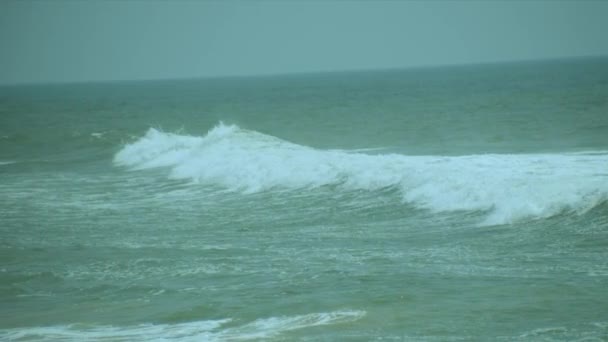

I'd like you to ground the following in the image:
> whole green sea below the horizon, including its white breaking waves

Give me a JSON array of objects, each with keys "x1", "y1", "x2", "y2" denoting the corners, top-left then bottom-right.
[{"x1": 0, "y1": 58, "x2": 608, "y2": 341}]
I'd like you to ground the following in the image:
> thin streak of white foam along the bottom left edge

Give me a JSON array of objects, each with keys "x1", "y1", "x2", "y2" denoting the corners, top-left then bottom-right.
[{"x1": 0, "y1": 311, "x2": 365, "y2": 342}]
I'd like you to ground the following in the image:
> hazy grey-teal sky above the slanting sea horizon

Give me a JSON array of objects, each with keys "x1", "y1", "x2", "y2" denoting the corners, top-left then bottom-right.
[{"x1": 0, "y1": 0, "x2": 608, "y2": 83}]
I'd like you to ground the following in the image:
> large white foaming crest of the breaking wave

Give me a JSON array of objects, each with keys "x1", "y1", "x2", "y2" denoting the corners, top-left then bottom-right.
[{"x1": 114, "y1": 124, "x2": 608, "y2": 224}]
